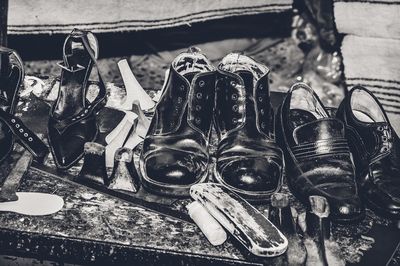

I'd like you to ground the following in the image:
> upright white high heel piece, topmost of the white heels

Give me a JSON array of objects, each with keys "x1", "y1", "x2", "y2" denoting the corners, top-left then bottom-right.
[{"x1": 118, "y1": 59, "x2": 155, "y2": 111}]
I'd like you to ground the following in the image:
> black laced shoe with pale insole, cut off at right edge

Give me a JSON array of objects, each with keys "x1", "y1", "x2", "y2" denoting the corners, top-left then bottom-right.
[{"x1": 336, "y1": 86, "x2": 400, "y2": 219}]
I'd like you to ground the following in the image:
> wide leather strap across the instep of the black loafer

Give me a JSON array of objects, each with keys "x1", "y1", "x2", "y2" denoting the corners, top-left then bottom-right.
[{"x1": 293, "y1": 118, "x2": 344, "y2": 144}]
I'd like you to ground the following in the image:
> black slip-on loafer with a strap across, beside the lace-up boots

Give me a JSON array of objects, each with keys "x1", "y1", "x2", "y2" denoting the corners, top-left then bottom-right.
[{"x1": 277, "y1": 83, "x2": 364, "y2": 222}]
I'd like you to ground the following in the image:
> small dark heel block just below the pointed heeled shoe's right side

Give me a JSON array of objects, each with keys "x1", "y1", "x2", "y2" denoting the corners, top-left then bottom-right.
[{"x1": 77, "y1": 142, "x2": 108, "y2": 185}]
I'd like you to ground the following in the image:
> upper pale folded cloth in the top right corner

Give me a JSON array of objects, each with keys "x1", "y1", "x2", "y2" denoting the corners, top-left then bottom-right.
[{"x1": 334, "y1": 0, "x2": 400, "y2": 39}]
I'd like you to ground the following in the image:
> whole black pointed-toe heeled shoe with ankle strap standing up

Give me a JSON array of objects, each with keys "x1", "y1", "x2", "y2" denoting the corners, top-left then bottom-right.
[{"x1": 48, "y1": 29, "x2": 106, "y2": 169}]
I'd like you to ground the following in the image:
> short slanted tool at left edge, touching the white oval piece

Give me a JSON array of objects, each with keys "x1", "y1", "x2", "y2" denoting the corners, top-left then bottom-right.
[{"x1": 0, "y1": 150, "x2": 33, "y2": 202}]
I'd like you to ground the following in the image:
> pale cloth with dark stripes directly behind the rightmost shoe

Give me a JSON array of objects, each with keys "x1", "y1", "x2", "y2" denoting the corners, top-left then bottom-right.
[{"x1": 341, "y1": 35, "x2": 400, "y2": 134}]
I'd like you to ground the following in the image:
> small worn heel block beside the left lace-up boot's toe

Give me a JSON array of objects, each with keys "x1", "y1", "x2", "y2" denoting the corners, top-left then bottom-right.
[{"x1": 108, "y1": 147, "x2": 140, "y2": 193}]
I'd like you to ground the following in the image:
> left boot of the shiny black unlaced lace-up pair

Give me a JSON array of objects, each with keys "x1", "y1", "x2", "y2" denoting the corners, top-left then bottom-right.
[{"x1": 139, "y1": 48, "x2": 215, "y2": 196}]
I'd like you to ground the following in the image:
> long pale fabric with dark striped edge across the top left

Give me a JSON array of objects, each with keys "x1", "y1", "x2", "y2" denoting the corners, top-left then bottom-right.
[{"x1": 8, "y1": 0, "x2": 293, "y2": 34}]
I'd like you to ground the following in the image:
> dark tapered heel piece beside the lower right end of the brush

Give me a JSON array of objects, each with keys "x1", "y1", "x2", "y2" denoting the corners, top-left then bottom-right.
[{"x1": 268, "y1": 193, "x2": 307, "y2": 265}]
